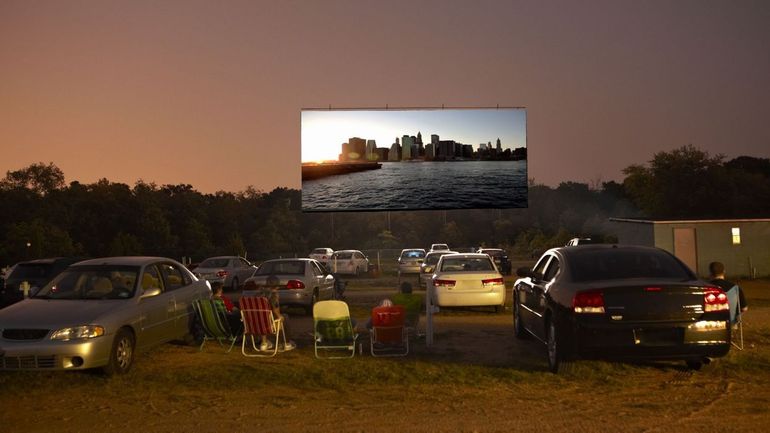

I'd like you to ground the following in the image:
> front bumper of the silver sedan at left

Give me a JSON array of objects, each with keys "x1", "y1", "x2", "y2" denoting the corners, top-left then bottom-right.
[{"x1": 0, "y1": 336, "x2": 113, "y2": 370}]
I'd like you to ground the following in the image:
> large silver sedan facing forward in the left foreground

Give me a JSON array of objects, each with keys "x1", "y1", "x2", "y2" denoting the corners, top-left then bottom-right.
[{"x1": 0, "y1": 257, "x2": 211, "y2": 374}]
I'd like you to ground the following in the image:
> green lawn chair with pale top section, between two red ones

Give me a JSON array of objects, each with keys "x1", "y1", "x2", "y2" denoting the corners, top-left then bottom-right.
[{"x1": 313, "y1": 301, "x2": 358, "y2": 359}]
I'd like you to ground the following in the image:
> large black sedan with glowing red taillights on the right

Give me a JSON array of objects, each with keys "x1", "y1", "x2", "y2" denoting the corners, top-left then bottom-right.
[{"x1": 513, "y1": 245, "x2": 730, "y2": 372}]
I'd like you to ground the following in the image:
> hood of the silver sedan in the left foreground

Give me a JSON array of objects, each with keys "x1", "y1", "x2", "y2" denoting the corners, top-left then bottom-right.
[{"x1": 0, "y1": 298, "x2": 128, "y2": 328}]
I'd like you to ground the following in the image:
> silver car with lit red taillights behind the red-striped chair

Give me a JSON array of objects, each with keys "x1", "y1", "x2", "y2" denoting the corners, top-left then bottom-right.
[{"x1": 243, "y1": 258, "x2": 335, "y2": 314}]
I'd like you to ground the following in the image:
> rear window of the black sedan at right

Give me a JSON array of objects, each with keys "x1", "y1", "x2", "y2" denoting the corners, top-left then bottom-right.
[{"x1": 569, "y1": 249, "x2": 694, "y2": 281}]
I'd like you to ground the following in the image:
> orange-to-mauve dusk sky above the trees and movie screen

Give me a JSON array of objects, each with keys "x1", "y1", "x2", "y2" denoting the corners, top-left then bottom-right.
[{"x1": 0, "y1": 0, "x2": 770, "y2": 192}]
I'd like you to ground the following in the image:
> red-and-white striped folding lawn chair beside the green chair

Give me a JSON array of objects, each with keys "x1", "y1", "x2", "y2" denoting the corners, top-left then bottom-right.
[{"x1": 240, "y1": 296, "x2": 286, "y2": 358}]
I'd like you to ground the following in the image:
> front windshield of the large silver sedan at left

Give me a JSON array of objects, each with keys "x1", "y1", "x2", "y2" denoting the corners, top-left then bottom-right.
[{"x1": 34, "y1": 266, "x2": 139, "y2": 299}]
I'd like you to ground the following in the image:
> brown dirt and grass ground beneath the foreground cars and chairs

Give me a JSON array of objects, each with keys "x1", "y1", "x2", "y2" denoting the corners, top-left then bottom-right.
[{"x1": 0, "y1": 282, "x2": 770, "y2": 433}]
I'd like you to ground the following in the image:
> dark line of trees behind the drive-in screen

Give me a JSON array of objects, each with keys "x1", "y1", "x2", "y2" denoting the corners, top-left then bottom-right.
[{"x1": 0, "y1": 145, "x2": 770, "y2": 265}]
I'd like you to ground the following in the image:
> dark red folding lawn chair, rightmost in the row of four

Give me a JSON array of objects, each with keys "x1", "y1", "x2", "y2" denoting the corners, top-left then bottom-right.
[{"x1": 369, "y1": 305, "x2": 409, "y2": 356}]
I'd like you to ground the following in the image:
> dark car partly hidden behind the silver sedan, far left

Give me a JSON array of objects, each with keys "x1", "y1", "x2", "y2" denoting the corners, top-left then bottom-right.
[{"x1": 0, "y1": 257, "x2": 84, "y2": 308}]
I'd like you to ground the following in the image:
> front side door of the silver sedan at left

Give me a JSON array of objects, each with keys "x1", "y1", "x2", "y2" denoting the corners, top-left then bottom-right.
[{"x1": 137, "y1": 264, "x2": 176, "y2": 347}]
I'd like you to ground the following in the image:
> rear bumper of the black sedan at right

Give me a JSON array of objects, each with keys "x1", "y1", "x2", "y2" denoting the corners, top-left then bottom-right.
[{"x1": 576, "y1": 321, "x2": 731, "y2": 360}]
